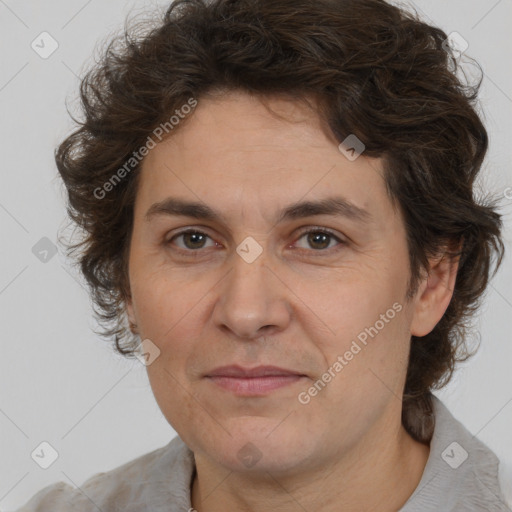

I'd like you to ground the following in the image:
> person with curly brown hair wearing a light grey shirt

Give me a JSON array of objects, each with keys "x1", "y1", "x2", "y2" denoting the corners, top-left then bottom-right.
[{"x1": 14, "y1": 0, "x2": 511, "y2": 512}]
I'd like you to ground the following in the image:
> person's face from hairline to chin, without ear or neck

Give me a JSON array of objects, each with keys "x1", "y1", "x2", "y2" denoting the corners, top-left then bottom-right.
[{"x1": 128, "y1": 93, "x2": 442, "y2": 475}]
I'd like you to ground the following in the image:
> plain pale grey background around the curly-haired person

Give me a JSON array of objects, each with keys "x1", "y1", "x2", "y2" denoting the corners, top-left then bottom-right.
[{"x1": 0, "y1": 0, "x2": 512, "y2": 510}]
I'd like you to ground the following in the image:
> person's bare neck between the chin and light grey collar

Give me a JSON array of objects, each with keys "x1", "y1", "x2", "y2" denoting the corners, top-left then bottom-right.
[{"x1": 191, "y1": 425, "x2": 430, "y2": 512}]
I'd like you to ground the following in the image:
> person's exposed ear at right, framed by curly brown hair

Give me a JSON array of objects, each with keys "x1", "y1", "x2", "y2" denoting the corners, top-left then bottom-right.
[{"x1": 410, "y1": 246, "x2": 459, "y2": 337}]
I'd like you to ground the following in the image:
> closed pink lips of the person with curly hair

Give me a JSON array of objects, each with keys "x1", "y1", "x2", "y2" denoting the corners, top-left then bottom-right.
[{"x1": 206, "y1": 366, "x2": 307, "y2": 396}]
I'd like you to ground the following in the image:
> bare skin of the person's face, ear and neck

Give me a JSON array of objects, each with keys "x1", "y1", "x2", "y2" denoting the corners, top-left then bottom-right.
[{"x1": 127, "y1": 92, "x2": 457, "y2": 512}]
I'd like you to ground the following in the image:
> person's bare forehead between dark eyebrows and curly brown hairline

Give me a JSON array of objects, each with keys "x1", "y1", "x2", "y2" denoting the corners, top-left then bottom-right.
[{"x1": 137, "y1": 93, "x2": 393, "y2": 230}]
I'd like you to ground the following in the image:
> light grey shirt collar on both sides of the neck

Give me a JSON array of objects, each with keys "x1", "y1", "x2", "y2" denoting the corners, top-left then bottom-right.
[{"x1": 144, "y1": 395, "x2": 509, "y2": 512}]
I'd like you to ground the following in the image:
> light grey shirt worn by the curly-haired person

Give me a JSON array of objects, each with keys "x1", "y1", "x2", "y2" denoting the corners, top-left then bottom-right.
[{"x1": 16, "y1": 396, "x2": 512, "y2": 512}]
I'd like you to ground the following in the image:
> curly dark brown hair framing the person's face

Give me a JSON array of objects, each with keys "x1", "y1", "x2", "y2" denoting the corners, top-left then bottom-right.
[{"x1": 55, "y1": 0, "x2": 504, "y2": 440}]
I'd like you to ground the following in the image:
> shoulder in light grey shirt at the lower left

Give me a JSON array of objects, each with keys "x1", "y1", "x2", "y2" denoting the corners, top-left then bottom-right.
[{"x1": 15, "y1": 437, "x2": 194, "y2": 512}]
